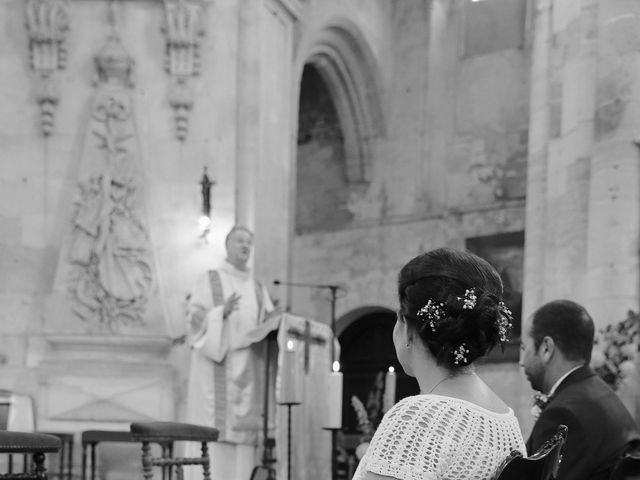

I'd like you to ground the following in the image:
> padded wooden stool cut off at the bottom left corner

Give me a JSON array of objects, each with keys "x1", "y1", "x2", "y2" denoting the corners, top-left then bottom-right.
[{"x1": 0, "y1": 430, "x2": 60, "y2": 480}]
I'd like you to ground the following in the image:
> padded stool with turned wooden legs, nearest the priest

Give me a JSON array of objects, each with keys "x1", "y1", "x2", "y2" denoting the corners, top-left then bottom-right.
[{"x1": 131, "y1": 422, "x2": 219, "y2": 480}]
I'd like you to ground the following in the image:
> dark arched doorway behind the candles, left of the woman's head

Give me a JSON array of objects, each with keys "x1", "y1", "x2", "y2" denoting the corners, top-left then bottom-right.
[{"x1": 337, "y1": 307, "x2": 419, "y2": 436}]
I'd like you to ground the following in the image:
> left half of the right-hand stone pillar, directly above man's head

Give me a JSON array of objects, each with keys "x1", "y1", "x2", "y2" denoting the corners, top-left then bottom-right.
[{"x1": 524, "y1": 0, "x2": 598, "y2": 318}]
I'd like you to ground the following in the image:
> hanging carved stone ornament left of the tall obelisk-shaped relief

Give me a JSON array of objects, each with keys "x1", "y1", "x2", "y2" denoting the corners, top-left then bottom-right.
[{"x1": 26, "y1": 0, "x2": 69, "y2": 137}]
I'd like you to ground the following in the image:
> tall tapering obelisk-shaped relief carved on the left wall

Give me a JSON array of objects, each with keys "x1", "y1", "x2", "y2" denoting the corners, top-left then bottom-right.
[{"x1": 68, "y1": 29, "x2": 154, "y2": 330}]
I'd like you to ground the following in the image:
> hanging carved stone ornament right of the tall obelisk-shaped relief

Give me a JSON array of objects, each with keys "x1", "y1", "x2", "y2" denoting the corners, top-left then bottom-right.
[{"x1": 162, "y1": 0, "x2": 205, "y2": 141}]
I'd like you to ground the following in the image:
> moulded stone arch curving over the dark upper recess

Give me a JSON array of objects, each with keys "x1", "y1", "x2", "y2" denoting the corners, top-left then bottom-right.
[{"x1": 303, "y1": 19, "x2": 384, "y2": 183}]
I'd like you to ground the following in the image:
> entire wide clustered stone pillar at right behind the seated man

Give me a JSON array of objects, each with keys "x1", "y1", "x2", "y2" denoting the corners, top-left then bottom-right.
[{"x1": 524, "y1": 0, "x2": 640, "y2": 327}]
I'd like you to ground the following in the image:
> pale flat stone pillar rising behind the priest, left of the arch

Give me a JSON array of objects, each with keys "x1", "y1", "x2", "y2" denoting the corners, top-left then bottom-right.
[{"x1": 236, "y1": 0, "x2": 297, "y2": 285}]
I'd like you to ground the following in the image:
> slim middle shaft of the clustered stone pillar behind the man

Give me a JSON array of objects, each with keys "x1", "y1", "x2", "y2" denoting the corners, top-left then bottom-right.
[{"x1": 544, "y1": 0, "x2": 597, "y2": 303}]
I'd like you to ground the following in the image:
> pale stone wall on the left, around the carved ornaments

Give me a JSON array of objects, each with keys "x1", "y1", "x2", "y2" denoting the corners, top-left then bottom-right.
[{"x1": 0, "y1": 0, "x2": 300, "y2": 428}]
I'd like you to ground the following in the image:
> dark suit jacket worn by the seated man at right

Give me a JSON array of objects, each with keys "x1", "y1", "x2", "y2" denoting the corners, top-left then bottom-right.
[{"x1": 527, "y1": 365, "x2": 640, "y2": 480}]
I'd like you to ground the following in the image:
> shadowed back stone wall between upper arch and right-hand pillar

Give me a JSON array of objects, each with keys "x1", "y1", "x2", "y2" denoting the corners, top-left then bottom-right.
[{"x1": 288, "y1": 1, "x2": 530, "y2": 432}]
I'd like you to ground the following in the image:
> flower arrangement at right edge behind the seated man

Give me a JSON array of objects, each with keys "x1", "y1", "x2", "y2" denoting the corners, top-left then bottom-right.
[{"x1": 591, "y1": 310, "x2": 640, "y2": 390}]
